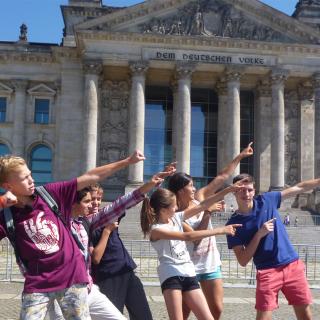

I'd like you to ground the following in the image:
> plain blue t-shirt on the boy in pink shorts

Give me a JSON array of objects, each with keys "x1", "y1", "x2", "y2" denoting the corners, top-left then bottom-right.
[{"x1": 227, "y1": 192, "x2": 299, "y2": 269}]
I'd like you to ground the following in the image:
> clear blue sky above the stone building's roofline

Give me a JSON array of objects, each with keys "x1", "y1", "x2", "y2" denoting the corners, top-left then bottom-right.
[{"x1": 0, "y1": 0, "x2": 298, "y2": 43}]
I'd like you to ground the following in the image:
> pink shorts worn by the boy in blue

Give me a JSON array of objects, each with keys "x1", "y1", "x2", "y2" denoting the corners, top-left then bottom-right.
[{"x1": 256, "y1": 260, "x2": 312, "y2": 311}]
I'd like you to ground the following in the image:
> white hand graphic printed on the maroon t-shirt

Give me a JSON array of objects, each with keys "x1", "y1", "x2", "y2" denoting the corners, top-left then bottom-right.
[{"x1": 23, "y1": 211, "x2": 59, "y2": 254}]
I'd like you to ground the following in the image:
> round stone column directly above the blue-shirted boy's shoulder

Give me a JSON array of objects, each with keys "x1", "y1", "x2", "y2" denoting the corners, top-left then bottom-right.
[{"x1": 270, "y1": 69, "x2": 288, "y2": 190}]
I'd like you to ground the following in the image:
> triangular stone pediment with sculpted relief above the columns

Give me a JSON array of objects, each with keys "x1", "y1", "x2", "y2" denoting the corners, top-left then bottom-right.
[{"x1": 76, "y1": 0, "x2": 320, "y2": 44}]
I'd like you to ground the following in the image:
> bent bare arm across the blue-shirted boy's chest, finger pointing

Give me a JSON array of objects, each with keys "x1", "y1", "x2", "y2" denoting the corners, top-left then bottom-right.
[{"x1": 233, "y1": 218, "x2": 275, "y2": 267}]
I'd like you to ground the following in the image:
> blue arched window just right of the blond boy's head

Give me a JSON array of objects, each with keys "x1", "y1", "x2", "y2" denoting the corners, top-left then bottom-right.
[{"x1": 30, "y1": 144, "x2": 52, "y2": 186}]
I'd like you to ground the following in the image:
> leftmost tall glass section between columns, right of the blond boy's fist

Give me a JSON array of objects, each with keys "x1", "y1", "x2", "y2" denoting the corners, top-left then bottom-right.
[{"x1": 144, "y1": 86, "x2": 173, "y2": 180}]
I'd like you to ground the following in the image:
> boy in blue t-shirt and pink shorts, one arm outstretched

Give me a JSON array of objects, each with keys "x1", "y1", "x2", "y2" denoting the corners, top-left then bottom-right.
[{"x1": 227, "y1": 174, "x2": 320, "y2": 320}]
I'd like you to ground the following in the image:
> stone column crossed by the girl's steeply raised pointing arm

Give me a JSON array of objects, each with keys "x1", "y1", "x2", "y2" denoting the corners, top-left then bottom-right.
[{"x1": 224, "y1": 68, "x2": 243, "y2": 176}]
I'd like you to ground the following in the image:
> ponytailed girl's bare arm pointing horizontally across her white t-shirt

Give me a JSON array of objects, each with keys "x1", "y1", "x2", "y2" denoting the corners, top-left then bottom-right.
[{"x1": 150, "y1": 224, "x2": 241, "y2": 241}]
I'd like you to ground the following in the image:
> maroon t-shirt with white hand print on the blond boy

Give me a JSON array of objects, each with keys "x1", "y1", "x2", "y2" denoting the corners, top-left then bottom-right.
[{"x1": 0, "y1": 179, "x2": 88, "y2": 293}]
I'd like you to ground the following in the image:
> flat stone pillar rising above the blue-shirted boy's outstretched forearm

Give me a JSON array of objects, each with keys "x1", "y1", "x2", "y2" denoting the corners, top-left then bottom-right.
[{"x1": 298, "y1": 85, "x2": 314, "y2": 181}]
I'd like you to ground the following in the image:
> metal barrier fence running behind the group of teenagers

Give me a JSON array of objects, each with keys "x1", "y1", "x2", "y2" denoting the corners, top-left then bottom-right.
[{"x1": 0, "y1": 239, "x2": 320, "y2": 286}]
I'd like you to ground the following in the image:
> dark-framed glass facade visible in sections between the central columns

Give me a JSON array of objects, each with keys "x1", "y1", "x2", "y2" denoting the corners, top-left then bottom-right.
[{"x1": 144, "y1": 86, "x2": 254, "y2": 188}]
